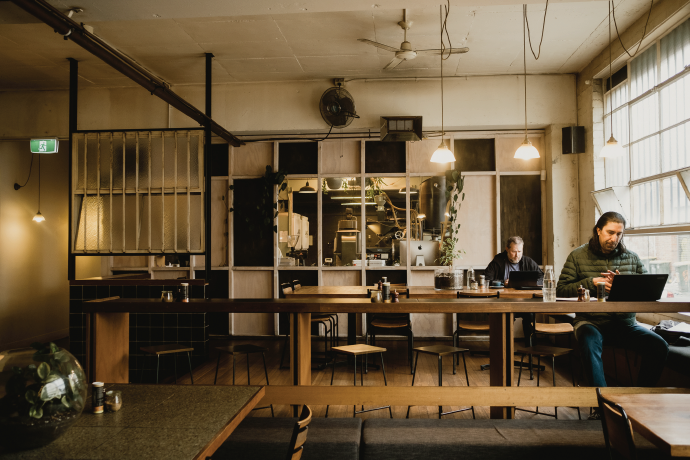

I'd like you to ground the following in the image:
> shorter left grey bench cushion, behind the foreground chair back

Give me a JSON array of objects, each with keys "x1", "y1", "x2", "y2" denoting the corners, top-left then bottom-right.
[{"x1": 213, "y1": 417, "x2": 362, "y2": 460}]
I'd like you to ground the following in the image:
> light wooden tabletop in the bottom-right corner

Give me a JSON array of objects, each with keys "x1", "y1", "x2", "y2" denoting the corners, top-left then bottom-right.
[{"x1": 606, "y1": 394, "x2": 690, "y2": 457}]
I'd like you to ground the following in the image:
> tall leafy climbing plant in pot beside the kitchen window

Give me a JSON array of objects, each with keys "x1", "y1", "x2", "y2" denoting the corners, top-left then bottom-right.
[{"x1": 434, "y1": 170, "x2": 465, "y2": 290}]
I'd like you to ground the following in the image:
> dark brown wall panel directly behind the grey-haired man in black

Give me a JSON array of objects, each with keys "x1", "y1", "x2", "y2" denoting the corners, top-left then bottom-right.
[{"x1": 500, "y1": 176, "x2": 542, "y2": 264}]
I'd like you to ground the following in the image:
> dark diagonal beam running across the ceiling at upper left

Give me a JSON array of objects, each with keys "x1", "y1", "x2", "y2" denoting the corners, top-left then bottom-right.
[{"x1": 11, "y1": 0, "x2": 243, "y2": 147}]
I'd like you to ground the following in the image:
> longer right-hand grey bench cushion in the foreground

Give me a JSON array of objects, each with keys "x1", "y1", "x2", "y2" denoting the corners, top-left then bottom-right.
[{"x1": 362, "y1": 419, "x2": 663, "y2": 460}]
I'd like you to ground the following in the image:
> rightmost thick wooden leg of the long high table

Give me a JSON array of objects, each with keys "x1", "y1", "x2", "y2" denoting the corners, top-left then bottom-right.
[{"x1": 489, "y1": 313, "x2": 515, "y2": 419}]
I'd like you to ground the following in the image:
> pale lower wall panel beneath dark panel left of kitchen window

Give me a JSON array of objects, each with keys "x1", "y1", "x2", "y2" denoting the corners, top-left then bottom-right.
[{"x1": 232, "y1": 270, "x2": 275, "y2": 335}]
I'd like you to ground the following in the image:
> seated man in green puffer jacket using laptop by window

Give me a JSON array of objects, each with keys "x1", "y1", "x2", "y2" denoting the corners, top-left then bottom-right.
[{"x1": 556, "y1": 212, "x2": 668, "y2": 394}]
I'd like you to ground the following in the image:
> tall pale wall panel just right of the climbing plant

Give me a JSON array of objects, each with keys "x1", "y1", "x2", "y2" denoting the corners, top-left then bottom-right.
[{"x1": 455, "y1": 176, "x2": 492, "y2": 267}]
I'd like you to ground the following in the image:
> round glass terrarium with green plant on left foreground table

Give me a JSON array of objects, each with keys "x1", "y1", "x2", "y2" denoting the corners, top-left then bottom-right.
[{"x1": 0, "y1": 343, "x2": 86, "y2": 451}]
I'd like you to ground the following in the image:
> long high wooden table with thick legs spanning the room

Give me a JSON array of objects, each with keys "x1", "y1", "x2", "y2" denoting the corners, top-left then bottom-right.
[{"x1": 83, "y1": 298, "x2": 690, "y2": 418}]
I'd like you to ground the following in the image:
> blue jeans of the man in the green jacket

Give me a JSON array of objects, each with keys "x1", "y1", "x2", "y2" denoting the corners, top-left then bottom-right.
[{"x1": 576, "y1": 321, "x2": 668, "y2": 387}]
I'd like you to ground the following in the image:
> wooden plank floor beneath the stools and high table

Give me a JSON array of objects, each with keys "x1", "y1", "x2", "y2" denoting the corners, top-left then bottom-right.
[{"x1": 169, "y1": 338, "x2": 589, "y2": 420}]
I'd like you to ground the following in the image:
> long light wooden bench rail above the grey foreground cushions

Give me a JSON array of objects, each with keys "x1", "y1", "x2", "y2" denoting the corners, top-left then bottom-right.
[{"x1": 261, "y1": 385, "x2": 690, "y2": 407}]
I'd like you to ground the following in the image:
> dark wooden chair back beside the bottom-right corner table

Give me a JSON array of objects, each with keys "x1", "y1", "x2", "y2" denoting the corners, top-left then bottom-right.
[{"x1": 597, "y1": 388, "x2": 637, "y2": 460}]
